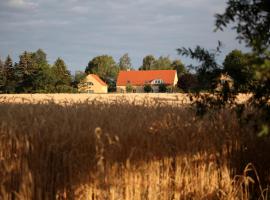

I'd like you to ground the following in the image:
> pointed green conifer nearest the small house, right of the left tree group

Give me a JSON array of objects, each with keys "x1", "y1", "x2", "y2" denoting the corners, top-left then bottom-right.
[{"x1": 51, "y1": 58, "x2": 72, "y2": 92}]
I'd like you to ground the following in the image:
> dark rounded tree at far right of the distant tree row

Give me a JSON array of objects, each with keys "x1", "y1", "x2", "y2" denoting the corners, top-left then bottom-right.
[{"x1": 223, "y1": 50, "x2": 255, "y2": 90}]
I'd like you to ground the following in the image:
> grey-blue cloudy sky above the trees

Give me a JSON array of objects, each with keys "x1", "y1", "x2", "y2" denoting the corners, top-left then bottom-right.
[{"x1": 0, "y1": 0, "x2": 246, "y2": 73}]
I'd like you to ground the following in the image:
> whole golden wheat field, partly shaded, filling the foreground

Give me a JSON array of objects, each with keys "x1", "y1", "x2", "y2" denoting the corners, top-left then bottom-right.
[{"x1": 0, "y1": 94, "x2": 270, "y2": 200}]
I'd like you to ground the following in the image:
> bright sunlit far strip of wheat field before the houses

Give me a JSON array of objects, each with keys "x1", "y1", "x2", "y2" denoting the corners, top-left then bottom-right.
[{"x1": 0, "y1": 93, "x2": 251, "y2": 105}]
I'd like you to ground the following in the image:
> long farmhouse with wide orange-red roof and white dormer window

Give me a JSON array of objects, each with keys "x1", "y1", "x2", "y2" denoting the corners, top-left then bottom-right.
[{"x1": 116, "y1": 70, "x2": 178, "y2": 92}]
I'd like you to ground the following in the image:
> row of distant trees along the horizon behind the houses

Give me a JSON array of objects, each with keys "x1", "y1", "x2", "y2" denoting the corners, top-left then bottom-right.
[{"x1": 0, "y1": 46, "x2": 260, "y2": 93}]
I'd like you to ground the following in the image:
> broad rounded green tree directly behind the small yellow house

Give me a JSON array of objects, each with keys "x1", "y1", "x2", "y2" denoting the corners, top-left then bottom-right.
[{"x1": 85, "y1": 55, "x2": 119, "y2": 80}]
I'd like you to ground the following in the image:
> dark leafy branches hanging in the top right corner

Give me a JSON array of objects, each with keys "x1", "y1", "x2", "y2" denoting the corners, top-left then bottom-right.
[{"x1": 215, "y1": 0, "x2": 270, "y2": 53}]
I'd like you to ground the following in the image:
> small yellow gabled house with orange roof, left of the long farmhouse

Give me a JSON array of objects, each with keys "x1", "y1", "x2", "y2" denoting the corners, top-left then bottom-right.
[{"x1": 78, "y1": 74, "x2": 108, "y2": 93}]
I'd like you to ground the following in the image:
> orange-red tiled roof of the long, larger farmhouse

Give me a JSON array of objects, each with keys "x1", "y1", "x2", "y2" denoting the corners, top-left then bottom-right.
[{"x1": 116, "y1": 70, "x2": 176, "y2": 86}]
